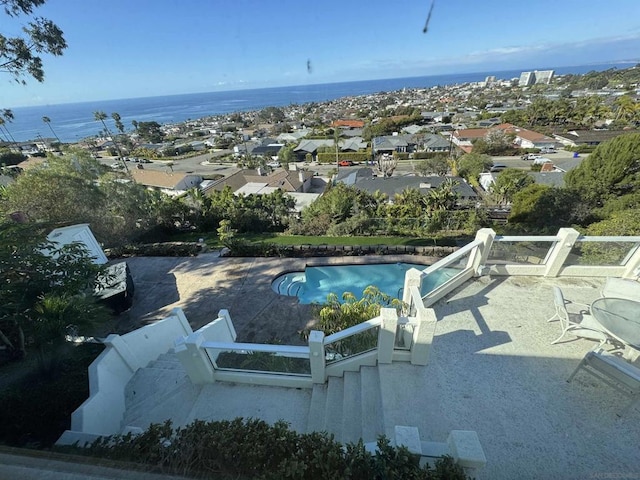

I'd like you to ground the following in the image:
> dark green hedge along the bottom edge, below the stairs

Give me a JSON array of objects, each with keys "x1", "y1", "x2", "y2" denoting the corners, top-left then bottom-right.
[{"x1": 63, "y1": 418, "x2": 467, "y2": 480}]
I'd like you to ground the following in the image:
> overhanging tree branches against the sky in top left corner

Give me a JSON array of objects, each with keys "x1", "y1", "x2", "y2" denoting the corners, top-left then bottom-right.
[{"x1": 0, "y1": 0, "x2": 67, "y2": 84}]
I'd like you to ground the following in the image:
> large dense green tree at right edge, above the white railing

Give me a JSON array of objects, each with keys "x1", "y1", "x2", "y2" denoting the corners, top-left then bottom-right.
[{"x1": 565, "y1": 133, "x2": 640, "y2": 207}]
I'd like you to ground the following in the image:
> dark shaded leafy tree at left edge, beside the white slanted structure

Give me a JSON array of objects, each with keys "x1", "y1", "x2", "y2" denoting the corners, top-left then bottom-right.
[{"x1": 0, "y1": 223, "x2": 104, "y2": 373}]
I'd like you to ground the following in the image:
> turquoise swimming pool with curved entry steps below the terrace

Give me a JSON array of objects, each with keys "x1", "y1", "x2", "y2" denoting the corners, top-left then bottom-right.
[{"x1": 271, "y1": 263, "x2": 459, "y2": 304}]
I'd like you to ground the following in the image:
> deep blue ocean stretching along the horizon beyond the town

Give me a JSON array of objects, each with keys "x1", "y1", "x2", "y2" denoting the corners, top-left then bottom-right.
[{"x1": 0, "y1": 62, "x2": 635, "y2": 142}]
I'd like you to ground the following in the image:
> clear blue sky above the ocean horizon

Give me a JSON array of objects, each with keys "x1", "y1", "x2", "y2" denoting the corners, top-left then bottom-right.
[{"x1": 0, "y1": 0, "x2": 640, "y2": 108}]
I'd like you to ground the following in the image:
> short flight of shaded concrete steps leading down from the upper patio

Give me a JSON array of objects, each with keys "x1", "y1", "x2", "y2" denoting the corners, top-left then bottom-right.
[{"x1": 307, "y1": 367, "x2": 384, "y2": 443}]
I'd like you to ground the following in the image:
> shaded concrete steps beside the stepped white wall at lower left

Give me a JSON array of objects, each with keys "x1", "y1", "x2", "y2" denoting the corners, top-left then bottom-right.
[{"x1": 121, "y1": 352, "x2": 201, "y2": 430}]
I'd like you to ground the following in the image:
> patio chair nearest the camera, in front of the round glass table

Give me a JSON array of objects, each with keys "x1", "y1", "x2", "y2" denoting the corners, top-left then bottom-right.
[{"x1": 567, "y1": 349, "x2": 640, "y2": 417}]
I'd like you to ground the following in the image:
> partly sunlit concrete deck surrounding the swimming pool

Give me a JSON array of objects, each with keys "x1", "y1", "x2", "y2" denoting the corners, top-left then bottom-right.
[{"x1": 111, "y1": 253, "x2": 439, "y2": 345}]
